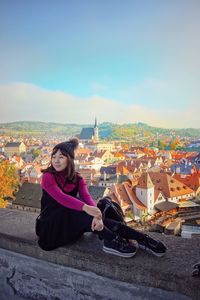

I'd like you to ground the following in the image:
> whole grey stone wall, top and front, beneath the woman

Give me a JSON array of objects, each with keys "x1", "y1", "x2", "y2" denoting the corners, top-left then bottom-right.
[{"x1": 0, "y1": 209, "x2": 200, "y2": 300}]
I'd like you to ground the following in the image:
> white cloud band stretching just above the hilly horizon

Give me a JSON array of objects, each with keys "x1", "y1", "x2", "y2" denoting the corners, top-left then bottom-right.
[{"x1": 0, "y1": 83, "x2": 200, "y2": 128}]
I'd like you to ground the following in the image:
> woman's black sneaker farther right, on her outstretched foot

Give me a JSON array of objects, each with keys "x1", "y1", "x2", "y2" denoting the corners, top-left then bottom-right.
[{"x1": 138, "y1": 234, "x2": 167, "y2": 257}]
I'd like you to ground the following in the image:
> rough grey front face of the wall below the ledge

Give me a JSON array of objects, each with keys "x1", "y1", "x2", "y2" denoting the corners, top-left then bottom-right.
[{"x1": 0, "y1": 248, "x2": 191, "y2": 300}]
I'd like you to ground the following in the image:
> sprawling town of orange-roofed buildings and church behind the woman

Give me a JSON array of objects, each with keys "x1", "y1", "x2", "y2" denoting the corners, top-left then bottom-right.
[{"x1": 0, "y1": 118, "x2": 200, "y2": 237}]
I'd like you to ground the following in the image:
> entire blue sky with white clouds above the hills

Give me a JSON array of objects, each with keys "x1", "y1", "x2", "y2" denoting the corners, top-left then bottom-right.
[{"x1": 0, "y1": 0, "x2": 200, "y2": 128}]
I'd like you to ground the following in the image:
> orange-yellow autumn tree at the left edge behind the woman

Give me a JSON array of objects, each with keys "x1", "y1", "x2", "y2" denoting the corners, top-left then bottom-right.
[{"x1": 0, "y1": 160, "x2": 19, "y2": 207}]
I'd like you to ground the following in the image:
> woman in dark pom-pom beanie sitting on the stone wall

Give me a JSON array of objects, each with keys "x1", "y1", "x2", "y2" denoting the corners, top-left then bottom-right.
[{"x1": 37, "y1": 138, "x2": 166, "y2": 257}]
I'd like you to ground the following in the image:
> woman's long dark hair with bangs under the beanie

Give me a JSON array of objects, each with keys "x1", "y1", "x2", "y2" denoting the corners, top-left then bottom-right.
[{"x1": 41, "y1": 147, "x2": 78, "y2": 183}]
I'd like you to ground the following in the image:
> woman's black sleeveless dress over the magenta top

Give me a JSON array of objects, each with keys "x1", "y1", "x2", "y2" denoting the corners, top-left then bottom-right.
[{"x1": 38, "y1": 185, "x2": 93, "y2": 251}]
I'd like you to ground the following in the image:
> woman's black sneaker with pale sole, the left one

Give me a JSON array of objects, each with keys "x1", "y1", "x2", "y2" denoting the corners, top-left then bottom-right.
[{"x1": 103, "y1": 236, "x2": 137, "y2": 258}]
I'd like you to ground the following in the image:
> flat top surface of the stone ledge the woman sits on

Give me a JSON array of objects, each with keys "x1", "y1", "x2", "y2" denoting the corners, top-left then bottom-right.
[{"x1": 0, "y1": 209, "x2": 200, "y2": 300}]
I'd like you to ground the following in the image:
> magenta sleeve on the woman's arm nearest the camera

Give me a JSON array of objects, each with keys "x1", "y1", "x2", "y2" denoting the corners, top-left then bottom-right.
[{"x1": 41, "y1": 173, "x2": 84, "y2": 211}]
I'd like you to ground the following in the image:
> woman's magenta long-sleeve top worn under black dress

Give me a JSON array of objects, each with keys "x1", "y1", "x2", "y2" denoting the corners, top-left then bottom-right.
[{"x1": 41, "y1": 172, "x2": 96, "y2": 211}]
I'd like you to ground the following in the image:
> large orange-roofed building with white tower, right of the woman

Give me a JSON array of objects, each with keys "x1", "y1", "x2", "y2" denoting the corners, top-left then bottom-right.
[{"x1": 110, "y1": 172, "x2": 195, "y2": 220}]
